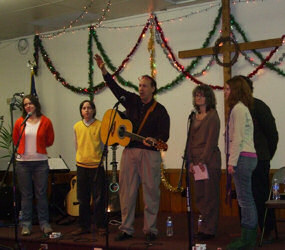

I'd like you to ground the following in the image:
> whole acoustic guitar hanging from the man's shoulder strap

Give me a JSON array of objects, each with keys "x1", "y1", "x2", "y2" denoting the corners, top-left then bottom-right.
[{"x1": 101, "y1": 109, "x2": 168, "y2": 151}]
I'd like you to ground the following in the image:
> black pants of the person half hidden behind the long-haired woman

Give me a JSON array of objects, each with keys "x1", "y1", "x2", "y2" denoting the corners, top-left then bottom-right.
[{"x1": 252, "y1": 160, "x2": 275, "y2": 233}]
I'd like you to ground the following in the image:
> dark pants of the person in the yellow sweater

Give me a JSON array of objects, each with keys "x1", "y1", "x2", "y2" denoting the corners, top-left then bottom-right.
[{"x1": 77, "y1": 166, "x2": 106, "y2": 229}]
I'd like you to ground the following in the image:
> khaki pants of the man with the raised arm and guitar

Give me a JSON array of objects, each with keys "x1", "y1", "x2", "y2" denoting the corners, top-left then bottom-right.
[{"x1": 119, "y1": 148, "x2": 161, "y2": 235}]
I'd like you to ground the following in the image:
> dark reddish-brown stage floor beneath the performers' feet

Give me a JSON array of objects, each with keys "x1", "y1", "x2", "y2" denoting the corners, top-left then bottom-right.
[{"x1": 0, "y1": 213, "x2": 285, "y2": 250}]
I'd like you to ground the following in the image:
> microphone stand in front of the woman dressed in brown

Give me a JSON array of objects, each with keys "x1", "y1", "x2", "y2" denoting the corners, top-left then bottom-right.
[{"x1": 182, "y1": 113, "x2": 194, "y2": 250}]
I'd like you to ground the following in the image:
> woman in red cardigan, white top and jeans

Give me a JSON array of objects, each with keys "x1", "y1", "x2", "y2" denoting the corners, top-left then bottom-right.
[{"x1": 13, "y1": 95, "x2": 54, "y2": 235}]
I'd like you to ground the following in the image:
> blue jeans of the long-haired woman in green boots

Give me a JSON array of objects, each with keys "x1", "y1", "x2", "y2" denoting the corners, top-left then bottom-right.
[{"x1": 233, "y1": 156, "x2": 258, "y2": 229}]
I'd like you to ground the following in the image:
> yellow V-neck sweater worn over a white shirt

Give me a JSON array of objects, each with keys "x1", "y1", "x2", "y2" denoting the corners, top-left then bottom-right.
[{"x1": 73, "y1": 119, "x2": 102, "y2": 168}]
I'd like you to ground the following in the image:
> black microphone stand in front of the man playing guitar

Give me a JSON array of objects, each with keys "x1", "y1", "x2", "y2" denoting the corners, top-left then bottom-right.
[{"x1": 94, "y1": 101, "x2": 120, "y2": 249}]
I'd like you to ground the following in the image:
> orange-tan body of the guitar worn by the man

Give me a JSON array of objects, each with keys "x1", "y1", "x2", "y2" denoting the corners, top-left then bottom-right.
[{"x1": 101, "y1": 109, "x2": 133, "y2": 147}]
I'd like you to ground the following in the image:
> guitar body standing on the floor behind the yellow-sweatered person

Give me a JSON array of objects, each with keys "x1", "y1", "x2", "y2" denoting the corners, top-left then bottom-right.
[{"x1": 66, "y1": 176, "x2": 79, "y2": 216}]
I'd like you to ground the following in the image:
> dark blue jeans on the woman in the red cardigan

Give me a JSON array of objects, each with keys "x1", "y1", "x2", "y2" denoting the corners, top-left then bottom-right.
[{"x1": 16, "y1": 161, "x2": 49, "y2": 229}]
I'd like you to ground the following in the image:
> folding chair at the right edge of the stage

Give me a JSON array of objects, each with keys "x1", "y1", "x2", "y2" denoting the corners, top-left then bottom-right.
[{"x1": 259, "y1": 167, "x2": 285, "y2": 246}]
